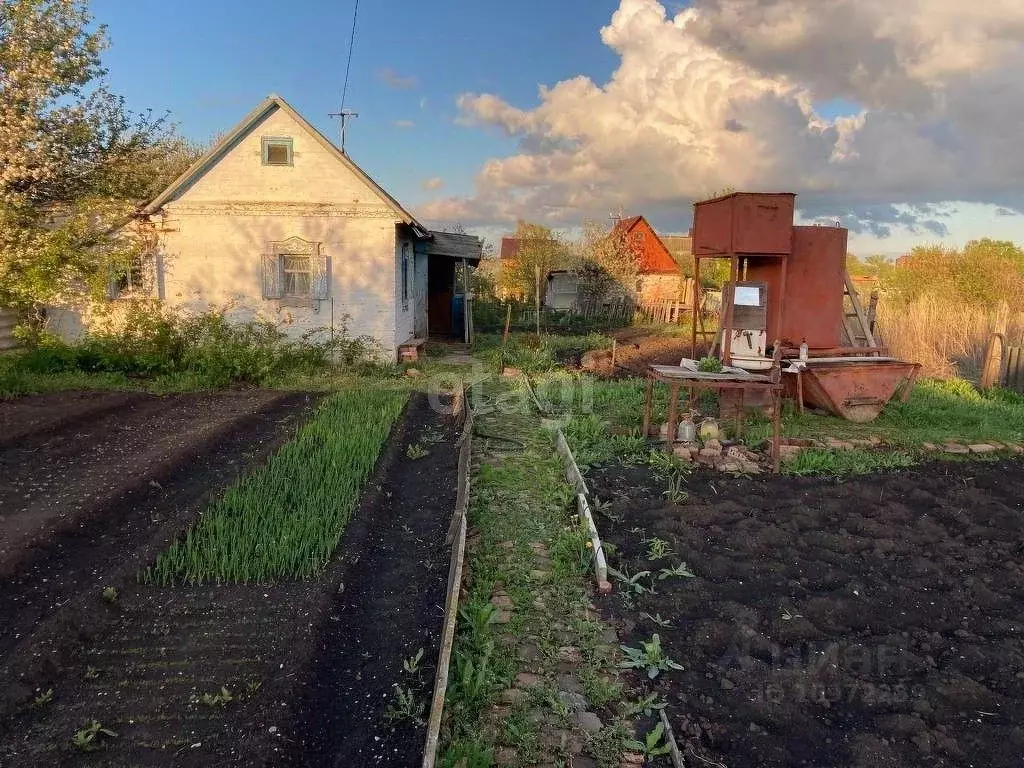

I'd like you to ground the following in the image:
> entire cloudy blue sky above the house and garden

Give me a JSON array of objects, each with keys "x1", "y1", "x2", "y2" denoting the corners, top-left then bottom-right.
[{"x1": 93, "y1": 0, "x2": 1024, "y2": 259}]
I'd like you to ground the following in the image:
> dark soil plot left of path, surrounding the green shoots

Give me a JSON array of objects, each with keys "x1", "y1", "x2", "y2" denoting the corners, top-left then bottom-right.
[{"x1": 0, "y1": 391, "x2": 457, "y2": 766}]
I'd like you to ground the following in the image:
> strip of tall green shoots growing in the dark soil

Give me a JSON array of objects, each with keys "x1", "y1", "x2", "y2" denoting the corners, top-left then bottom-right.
[{"x1": 141, "y1": 390, "x2": 406, "y2": 586}]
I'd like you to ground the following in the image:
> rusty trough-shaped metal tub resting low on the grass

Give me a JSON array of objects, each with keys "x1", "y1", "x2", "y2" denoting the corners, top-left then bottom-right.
[{"x1": 785, "y1": 357, "x2": 921, "y2": 423}]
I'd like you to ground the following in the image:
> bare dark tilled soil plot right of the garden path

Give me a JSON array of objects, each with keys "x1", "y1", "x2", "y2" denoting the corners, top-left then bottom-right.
[{"x1": 589, "y1": 461, "x2": 1024, "y2": 768}]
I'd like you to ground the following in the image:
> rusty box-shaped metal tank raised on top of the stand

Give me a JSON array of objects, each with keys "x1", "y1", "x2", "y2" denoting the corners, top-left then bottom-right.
[{"x1": 693, "y1": 193, "x2": 797, "y2": 257}]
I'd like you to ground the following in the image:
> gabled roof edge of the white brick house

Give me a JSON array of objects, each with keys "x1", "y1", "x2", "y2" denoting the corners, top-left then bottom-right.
[{"x1": 142, "y1": 93, "x2": 427, "y2": 236}]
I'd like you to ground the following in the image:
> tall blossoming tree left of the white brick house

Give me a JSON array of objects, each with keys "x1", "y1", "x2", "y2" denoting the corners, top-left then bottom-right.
[{"x1": 0, "y1": 0, "x2": 199, "y2": 306}]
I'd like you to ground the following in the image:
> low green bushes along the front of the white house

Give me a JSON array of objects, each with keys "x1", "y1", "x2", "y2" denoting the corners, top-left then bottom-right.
[{"x1": 9, "y1": 305, "x2": 373, "y2": 387}]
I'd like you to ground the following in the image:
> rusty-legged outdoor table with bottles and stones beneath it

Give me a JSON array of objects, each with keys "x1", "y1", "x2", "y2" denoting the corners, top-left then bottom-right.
[{"x1": 643, "y1": 362, "x2": 782, "y2": 472}]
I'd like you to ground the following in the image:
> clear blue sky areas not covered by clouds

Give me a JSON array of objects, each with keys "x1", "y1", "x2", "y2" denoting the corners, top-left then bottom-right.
[{"x1": 90, "y1": 0, "x2": 1024, "y2": 260}]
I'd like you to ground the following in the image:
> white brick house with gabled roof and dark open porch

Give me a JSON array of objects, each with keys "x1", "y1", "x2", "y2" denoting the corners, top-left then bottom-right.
[{"x1": 45, "y1": 95, "x2": 480, "y2": 359}]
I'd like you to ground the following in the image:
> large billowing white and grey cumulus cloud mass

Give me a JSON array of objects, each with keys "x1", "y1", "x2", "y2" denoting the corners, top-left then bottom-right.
[{"x1": 420, "y1": 0, "x2": 1024, "y2": 234}]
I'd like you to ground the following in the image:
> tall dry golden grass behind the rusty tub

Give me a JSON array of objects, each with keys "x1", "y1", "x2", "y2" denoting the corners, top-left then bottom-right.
[{"x1": 878, "y1": 296, "x2": 1024, "y2": 380}]
